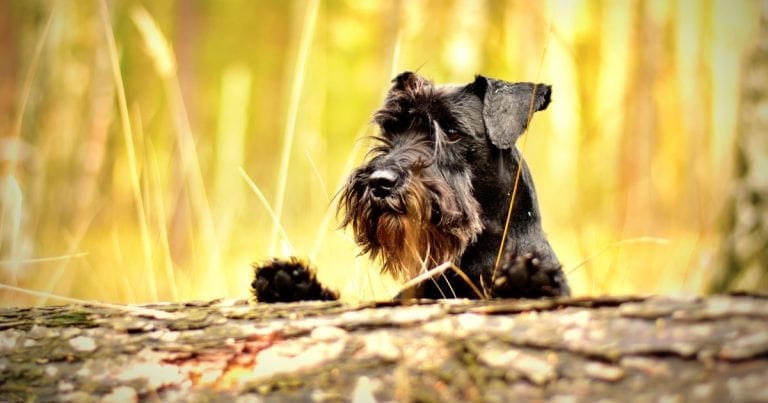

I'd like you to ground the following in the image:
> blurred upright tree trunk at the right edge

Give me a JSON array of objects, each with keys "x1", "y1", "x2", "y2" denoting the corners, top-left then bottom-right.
[{"x1": 711, "y1": 0, "x2": 768, "y2": 292}]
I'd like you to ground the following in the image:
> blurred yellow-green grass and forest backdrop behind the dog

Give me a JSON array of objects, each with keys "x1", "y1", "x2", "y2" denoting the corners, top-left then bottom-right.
[{"x1": 0, "y1": 0, "x2": 759, "y2": 305}]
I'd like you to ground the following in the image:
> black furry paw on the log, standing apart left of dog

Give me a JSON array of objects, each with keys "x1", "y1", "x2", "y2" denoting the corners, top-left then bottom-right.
[{"x1": 251, "y1": 258, "x2": 339, "y2": 302}]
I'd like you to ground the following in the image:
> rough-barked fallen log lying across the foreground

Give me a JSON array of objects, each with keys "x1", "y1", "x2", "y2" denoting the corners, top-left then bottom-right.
[{"x1": 0, "y1": 295, "x2": 768, "y2": 402}]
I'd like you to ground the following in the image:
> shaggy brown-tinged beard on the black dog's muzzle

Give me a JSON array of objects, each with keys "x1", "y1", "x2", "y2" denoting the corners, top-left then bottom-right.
[{"x1": 339, "y1": 170, "x2": 482, "y2": 280}]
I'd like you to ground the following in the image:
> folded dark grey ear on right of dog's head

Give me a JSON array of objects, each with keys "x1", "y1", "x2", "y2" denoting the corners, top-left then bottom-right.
[{"x1": 467, "y1": 75, "x2": 552, "y2": 149}]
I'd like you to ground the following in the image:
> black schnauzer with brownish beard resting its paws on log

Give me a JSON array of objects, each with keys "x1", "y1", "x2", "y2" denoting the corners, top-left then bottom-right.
[{"x1": 252, "y1": 72, "x2": 569, "y2": 302}]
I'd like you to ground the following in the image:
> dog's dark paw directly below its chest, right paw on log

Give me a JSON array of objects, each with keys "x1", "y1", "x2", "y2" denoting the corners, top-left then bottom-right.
[{"x1": 490, "y1": 253, "x2": 570, "y2": 298}]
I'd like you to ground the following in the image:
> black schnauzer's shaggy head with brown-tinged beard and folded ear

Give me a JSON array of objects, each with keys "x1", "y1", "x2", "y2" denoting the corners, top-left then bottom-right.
[{"x1": 339, "y1": 72, "x2": 551, "y2": 278}]
